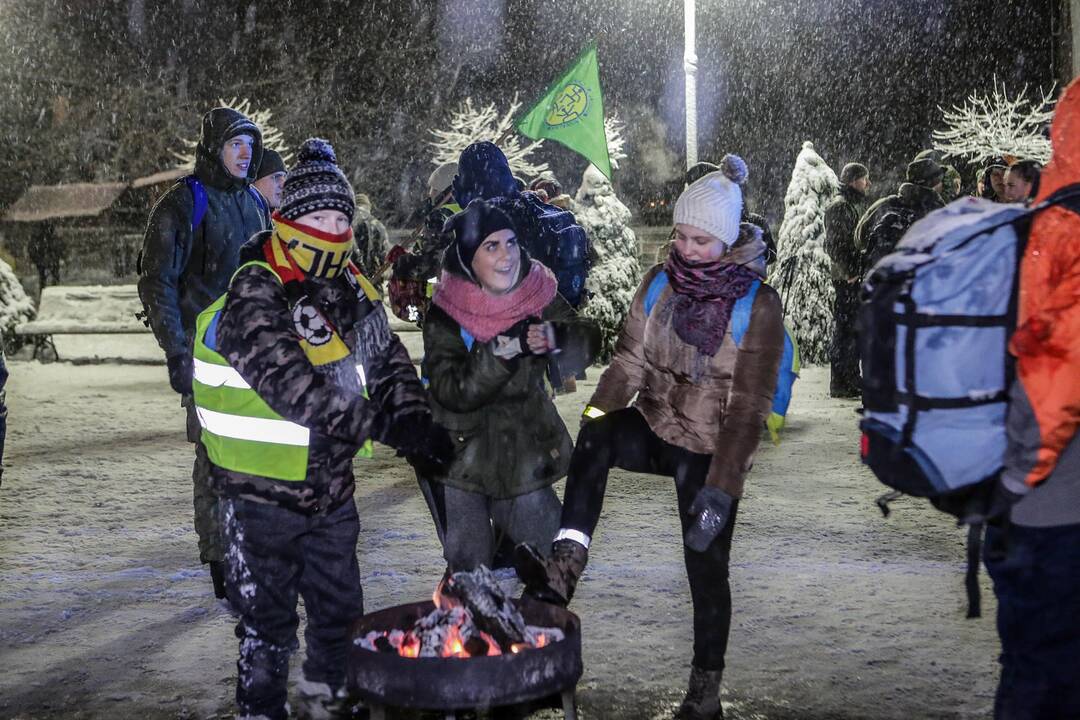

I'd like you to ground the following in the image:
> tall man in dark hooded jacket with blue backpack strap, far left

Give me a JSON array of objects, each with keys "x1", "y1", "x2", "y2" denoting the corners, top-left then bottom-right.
[{"x1": 138, "y1": 107, "x2": 270, "y2": 598}]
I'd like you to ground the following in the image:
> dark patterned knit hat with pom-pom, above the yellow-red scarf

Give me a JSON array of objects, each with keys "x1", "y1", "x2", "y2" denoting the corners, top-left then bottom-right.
[{"x1": 279, "y1": 137, "x2": 356, "y2": 223}]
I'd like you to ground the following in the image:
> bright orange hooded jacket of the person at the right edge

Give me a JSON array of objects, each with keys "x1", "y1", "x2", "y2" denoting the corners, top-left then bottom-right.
[{"x1": 1007, "y1": 77, "x2": 1080, "y2": 487}]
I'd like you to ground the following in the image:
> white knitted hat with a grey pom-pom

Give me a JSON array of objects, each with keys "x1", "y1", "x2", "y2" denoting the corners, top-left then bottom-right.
[{"x1": 674, "y1": 154, "x2": 748, "y2": 247}]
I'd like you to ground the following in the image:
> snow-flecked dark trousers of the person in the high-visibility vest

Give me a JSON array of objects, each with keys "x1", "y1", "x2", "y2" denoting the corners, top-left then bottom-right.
[{"x1": 220, "y1": 499, "x2": 364, "y2": 720}]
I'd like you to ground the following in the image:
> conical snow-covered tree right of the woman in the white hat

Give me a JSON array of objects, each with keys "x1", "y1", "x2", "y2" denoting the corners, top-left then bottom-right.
[{"x1": 775, "y1": 141, "x2": 839, "y2": 363}]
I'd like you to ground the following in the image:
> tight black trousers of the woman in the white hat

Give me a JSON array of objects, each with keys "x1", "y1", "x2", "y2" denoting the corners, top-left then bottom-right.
[{"x1": 562, "y1": 408, "x2": 739, "y2": 670}]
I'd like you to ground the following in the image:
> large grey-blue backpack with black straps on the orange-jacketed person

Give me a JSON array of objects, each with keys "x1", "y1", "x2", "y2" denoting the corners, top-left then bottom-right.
[{"x1": 858, "y1": 186, "x2": 1080, "y2": 615}]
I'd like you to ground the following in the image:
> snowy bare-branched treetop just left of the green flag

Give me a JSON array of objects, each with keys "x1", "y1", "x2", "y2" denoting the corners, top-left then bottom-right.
[{"x1": 428, "y1": 93, "x2": 548, "y2": 178}]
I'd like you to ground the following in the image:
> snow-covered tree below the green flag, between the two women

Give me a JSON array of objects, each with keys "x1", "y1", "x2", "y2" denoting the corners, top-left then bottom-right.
[{"x1": 573, "y1": 113, "x2": 642, "y2": 363}]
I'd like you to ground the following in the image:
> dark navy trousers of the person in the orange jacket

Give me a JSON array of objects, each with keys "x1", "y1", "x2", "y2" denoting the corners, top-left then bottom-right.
[{"x1": 984, "y1": 525, "x2": 1080, "y2": 720}]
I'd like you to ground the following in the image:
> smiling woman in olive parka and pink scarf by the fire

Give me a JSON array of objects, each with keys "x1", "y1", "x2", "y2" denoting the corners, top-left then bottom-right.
[{"x1": 423, "y1": 200, "x2": 600, "y2": 571}]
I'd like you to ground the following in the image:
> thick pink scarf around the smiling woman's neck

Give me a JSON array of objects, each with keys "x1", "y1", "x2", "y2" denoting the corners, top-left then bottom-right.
[{"x1": 431, "y1": 260, "x2": 558, "y2": 342}]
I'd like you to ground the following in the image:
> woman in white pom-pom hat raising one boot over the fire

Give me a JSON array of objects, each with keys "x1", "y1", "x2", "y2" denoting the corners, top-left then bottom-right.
[{"x1": 517, "y1": 155, "x2": 784, "y2": 720}]
